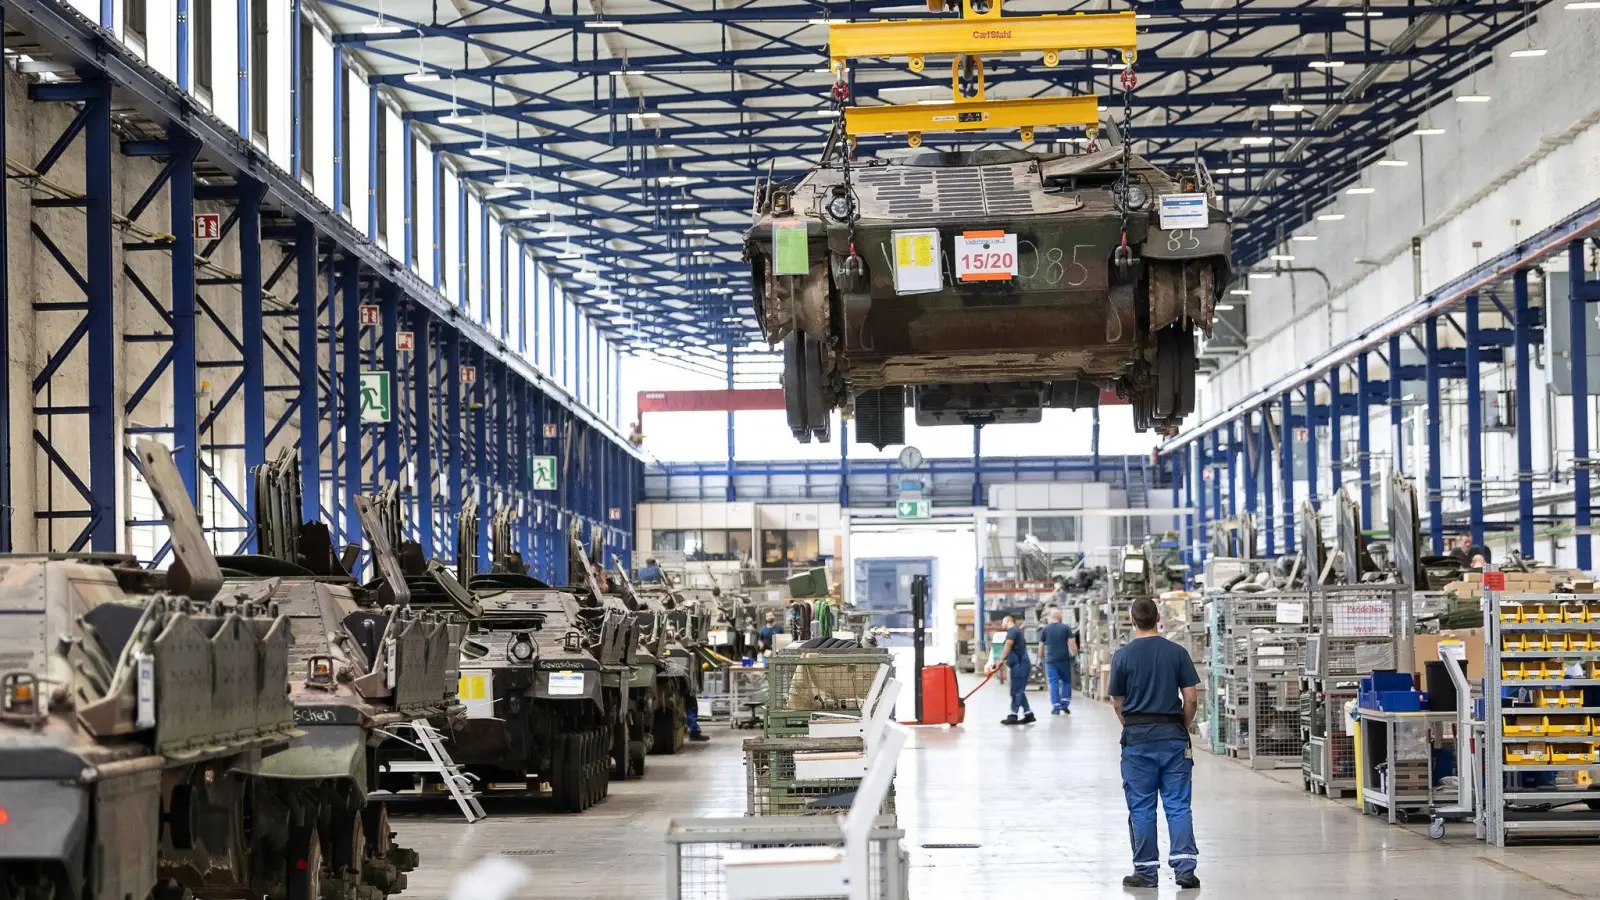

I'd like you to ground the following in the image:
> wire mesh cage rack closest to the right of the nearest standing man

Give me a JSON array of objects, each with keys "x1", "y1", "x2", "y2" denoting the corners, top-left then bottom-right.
[{"x1": 1213, "y1": 591, "x2": 1310, "y2": 769}]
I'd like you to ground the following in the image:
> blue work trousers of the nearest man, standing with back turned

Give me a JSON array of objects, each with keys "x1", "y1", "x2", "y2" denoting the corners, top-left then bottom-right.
[{"x1": 1122, "y1": 740, "x2": 1200, "y2": 879}]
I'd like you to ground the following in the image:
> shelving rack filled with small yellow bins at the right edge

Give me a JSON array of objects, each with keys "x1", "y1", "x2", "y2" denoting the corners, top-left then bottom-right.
[{"x1": 1480, "y1": 589, "x2": 1600, "y2": 847}]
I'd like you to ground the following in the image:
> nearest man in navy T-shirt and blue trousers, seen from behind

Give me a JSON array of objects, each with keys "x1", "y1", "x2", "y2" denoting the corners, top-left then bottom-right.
[{"x1": 1110, "y1": 597, "x2": 1200, "y2": 889}]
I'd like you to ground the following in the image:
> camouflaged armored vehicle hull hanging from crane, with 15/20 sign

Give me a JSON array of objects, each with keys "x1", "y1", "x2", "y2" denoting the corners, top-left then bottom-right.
[{"x1": 746, "y1": 147, "x2": 1230, "y2": 447}]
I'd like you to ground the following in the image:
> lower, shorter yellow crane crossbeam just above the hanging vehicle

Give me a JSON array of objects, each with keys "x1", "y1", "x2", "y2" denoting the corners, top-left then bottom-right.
[{"x1": 845, "y1": 94, "x2": 1099, "y2": 147}]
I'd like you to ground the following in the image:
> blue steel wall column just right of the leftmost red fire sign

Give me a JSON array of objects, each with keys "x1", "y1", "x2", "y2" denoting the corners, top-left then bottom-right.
[{"x1": 236, "y1": 179, "x2": 265, "y2": 552}]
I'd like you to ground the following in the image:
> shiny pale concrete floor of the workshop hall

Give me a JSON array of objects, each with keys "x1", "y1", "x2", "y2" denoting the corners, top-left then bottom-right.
[{"x1": 395, "y1": 675, "x2": 1600, "y2": 900}]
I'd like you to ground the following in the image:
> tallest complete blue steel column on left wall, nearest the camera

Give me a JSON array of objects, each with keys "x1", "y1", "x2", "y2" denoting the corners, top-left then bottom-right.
[{"x1": 84, "y1": 80, "x2": 116, "y2": 552}]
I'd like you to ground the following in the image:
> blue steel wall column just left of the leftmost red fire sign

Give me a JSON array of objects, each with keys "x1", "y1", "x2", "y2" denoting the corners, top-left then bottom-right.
[{"x1": 166, "y1": 128, "x2": 200, "y2": 496}]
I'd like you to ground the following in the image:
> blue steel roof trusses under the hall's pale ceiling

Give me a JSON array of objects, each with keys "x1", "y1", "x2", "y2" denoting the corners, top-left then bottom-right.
[{"x1": 305, "y1": 0, "x2": 1542, "y2": 346}]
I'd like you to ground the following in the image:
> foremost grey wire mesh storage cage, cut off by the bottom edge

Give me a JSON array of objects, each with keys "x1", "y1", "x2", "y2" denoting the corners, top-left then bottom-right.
[{"x1": 666, "y1": 818, "x2": 910, "y2": 900}]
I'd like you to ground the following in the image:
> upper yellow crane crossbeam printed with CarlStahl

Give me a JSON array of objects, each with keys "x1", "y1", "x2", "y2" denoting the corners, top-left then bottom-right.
[{"x1": 827, "y1": 11, "x2": 1138, "y2": 72}]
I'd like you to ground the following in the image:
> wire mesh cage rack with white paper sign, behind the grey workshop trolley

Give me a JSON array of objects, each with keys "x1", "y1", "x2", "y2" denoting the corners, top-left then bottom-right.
[{"x1": 1299, "y1": 585, "x2": 1414, "y2": 796}]
